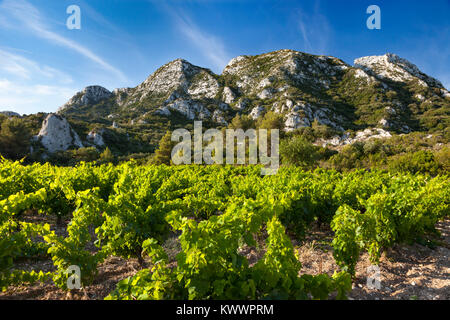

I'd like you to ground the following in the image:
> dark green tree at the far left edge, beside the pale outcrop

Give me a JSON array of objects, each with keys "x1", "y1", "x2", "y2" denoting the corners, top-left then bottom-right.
[{"x1": 0, "y1": 118, "x2": 31, "y2": 160}]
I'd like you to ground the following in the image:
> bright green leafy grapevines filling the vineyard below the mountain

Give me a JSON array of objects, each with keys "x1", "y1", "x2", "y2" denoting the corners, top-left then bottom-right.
[{"x1": 0, "y1": 159, "x2": 450, "y2": 300}]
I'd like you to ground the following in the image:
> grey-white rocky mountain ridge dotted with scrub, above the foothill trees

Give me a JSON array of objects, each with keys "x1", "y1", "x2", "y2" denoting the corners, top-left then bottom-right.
[{"x1": 33, "y1": 50, "x2": 450, "y2": 151}]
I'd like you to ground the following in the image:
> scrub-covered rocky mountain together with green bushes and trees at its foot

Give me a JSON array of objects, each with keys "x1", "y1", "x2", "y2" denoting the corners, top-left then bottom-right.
[{"x1": 0, "y1": 50, "x2": 450, "y2": 172}]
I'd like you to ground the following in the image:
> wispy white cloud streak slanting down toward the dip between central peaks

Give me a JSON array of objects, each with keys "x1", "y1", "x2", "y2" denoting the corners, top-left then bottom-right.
[{"x1": 164, "y1": 4, "x2": 231, "y2": 71}]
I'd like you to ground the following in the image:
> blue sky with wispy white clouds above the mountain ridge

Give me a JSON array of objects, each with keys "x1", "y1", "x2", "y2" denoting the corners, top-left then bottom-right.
[{"x1": 0, "y1": 0, "x2": 450, "y2": 114}]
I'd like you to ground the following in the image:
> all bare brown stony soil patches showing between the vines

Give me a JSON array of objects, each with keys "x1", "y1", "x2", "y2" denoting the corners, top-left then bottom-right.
[{"x1": 0, "y1": 217, "x2": 450, "y2": 300}]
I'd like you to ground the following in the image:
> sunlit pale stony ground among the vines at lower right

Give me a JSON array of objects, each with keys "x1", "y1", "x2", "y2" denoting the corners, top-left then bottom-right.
[{"x1": 298, "y1": 219, "x2": 450, "y2": 300}]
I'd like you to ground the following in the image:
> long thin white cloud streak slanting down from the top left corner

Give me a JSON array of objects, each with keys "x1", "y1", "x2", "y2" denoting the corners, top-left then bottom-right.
[{"x1": 0, "y1": 0, "x2": 126, "y2": 81}]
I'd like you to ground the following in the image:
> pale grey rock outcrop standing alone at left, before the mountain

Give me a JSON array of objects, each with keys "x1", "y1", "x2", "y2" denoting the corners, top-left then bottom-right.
[{"x1": 36, "y1": 114, "x2": 83, "y2": 153}]
